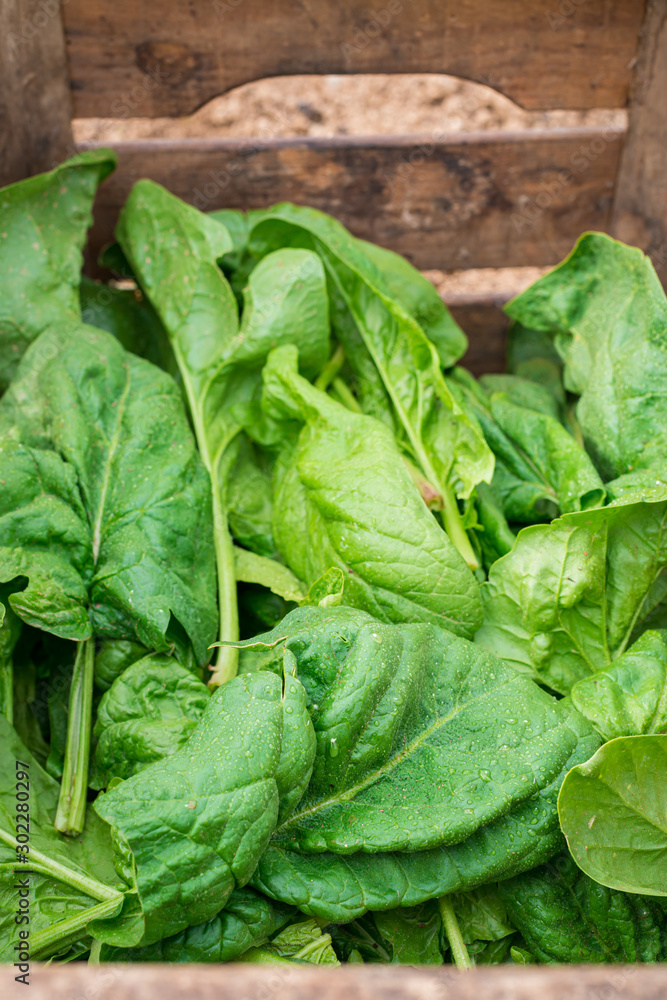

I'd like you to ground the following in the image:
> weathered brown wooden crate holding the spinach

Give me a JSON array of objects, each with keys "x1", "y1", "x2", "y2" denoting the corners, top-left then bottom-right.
[{"x1": 0, "y1": 0, "x2": 667, "y2": 1000}]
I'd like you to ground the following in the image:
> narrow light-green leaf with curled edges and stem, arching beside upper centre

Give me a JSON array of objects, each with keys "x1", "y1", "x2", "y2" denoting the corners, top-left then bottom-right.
[{"x1": 248, "y1": 204, "x2": 493, "y2": 567}]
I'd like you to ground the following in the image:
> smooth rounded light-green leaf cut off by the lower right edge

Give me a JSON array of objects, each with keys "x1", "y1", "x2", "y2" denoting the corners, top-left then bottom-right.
[{"x1": 558, "y1": 736, "x2": 667, "y2": 896}]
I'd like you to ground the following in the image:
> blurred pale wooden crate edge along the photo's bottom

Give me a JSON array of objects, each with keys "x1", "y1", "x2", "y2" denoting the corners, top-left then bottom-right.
[{"x1": 9, "y1": 963, "x2": 667, "y2": 1000}]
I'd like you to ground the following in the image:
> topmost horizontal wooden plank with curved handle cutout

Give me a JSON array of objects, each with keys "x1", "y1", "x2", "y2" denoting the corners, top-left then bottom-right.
[{"x1": 64, "y1": 0, "x2": 644, "y2": 118}]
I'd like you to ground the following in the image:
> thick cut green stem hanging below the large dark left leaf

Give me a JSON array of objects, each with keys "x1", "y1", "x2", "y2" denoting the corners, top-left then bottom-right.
[{"x1": 54, "y1": 638, "x2": 95, "y2": 836}]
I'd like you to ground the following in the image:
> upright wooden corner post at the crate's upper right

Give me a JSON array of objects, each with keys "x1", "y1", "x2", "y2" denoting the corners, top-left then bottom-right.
[{"x1": 612, "y1": 0, "x2": 667, "y2": 285}]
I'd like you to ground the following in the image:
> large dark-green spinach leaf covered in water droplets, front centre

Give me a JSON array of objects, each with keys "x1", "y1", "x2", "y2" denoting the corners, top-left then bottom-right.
[{"x1": 226, "y1": 607, "x2": 598, "y2": 921}]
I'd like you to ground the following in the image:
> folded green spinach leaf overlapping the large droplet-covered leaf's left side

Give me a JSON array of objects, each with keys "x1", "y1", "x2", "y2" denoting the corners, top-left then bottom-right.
[{"x1": 95, "y1": 673, "x2": 314, "y2": 944}]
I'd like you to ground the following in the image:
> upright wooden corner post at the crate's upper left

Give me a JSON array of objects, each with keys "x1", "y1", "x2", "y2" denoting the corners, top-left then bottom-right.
[{"x1": 0, "y1": 0, "x2": 73, "y2": 187}]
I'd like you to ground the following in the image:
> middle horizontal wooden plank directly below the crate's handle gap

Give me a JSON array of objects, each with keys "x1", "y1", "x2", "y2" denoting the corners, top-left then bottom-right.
[{"x1": 81, "y1": 129, "x2": 623, "y2": 271}]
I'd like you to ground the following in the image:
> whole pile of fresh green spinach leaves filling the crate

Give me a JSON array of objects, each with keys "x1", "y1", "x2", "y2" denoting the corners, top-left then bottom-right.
[{"x1": 0, "y1": 150, "x2": 667, "y2": 967}]
